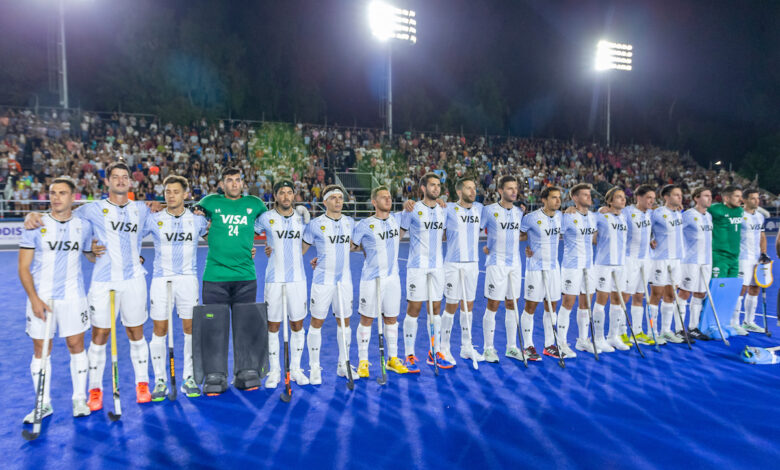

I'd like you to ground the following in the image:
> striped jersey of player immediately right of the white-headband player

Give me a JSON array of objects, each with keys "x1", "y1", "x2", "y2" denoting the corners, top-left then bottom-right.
[{"x1": 352, "y1": 212, "x2": 403, "y2": 281}]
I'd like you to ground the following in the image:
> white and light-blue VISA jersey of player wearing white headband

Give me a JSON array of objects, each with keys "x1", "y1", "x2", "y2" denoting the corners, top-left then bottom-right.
[{"x1": 303, "y1": 214, "x2": 355, "y2": 286}]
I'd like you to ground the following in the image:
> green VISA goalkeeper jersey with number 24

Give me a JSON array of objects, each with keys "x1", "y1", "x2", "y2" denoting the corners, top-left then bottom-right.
[{"x1": 198, "y1": 194, "x2": 268, "y2": 282}]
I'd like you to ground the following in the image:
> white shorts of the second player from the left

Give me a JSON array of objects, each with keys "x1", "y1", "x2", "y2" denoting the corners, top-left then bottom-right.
[{"x1": 87, "y1": 276, "x2": 149, "y2": 328}]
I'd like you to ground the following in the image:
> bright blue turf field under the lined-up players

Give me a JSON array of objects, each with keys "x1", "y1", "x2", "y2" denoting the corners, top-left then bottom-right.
[{"x1": 0, "y1": 239, "x2": 780, "y2": 469}]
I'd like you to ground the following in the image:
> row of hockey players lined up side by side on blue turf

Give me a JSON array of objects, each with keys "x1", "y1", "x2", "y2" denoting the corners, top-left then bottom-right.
[{"x1": 19, "y1": 162, "x2": 767, "y2": 430}]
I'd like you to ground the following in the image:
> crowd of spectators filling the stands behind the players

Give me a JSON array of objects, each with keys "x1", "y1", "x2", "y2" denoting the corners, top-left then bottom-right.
[{"x1": 0, "y1": 109, "x2": 780, "y2": 216}]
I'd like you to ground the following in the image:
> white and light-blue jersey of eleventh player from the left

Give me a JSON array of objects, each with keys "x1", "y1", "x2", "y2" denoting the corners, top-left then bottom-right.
[{"x1": 520, "y1": 209, "x2": 561, "y2": 271}]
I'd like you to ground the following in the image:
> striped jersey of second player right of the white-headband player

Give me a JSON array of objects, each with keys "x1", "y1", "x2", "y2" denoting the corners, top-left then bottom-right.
[{"x1": 401, "y1": 201, "x2": 445, "y2": 269}]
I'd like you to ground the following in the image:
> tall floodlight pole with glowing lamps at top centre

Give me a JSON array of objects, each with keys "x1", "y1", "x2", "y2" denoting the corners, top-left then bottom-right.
[{"x1": 368, "y1": 1, "x2": 417, "y2": 139}]
